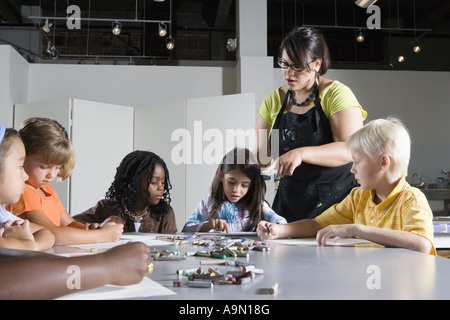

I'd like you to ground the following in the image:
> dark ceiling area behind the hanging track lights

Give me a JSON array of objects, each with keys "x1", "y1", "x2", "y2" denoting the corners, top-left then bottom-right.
[{"x1": 0, "y1": 0, "x2": 450, "y2": 71}]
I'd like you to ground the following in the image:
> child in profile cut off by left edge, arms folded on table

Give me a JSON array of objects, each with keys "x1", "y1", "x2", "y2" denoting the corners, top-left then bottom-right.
[{"x1": 0, "y1": 125, "x2": 55, "y2": 250}]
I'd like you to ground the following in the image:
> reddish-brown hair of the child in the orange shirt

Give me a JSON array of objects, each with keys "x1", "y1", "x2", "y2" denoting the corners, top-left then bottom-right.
[{"x1": 19, "y1": 117, "x2": 75, "y2": 180}]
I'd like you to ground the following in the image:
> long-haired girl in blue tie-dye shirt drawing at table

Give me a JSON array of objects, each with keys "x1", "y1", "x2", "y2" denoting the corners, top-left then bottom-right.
[{"x1": 183, "y1": 148, "x2": 286, "y2": 232}]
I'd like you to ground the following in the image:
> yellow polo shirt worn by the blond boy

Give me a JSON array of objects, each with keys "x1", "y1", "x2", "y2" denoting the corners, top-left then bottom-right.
[{"x1": 315, "y1": 177, "x2": 436, "y2": 254}]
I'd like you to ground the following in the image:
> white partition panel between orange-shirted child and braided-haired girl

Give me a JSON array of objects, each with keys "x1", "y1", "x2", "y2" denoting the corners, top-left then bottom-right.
[{"x1": 69, "y1": 99, "x2": 134, "y2": 215}]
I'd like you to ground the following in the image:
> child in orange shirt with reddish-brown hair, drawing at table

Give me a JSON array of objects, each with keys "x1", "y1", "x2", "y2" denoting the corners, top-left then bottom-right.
[{"x1": 9, "y1": 118, "x2": 123, "y2": 245}]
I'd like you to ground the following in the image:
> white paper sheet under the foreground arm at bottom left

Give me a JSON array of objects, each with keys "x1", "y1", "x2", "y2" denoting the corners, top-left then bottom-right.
[{"x1": 57, "y1": 277, "x2": 176, "y2": 300}]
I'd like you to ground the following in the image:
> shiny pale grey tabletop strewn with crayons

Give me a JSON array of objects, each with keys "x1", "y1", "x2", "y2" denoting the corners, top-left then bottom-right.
[{"x1": 49, "y1": 233, "x2": 450, "y2": 302}]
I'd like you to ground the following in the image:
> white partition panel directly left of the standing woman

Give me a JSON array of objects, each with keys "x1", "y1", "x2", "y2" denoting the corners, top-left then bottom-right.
[{"x1": 186, "y1": 93, "x2": 255, "y2": 225}]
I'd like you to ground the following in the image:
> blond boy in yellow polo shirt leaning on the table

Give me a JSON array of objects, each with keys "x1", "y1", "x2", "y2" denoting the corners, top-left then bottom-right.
[{"x1": 257, "y1": 118, "x2": 436, "y2": 254}]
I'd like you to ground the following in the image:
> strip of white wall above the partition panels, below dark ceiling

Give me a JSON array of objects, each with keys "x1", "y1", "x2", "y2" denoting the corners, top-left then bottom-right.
[{"x1": 28, "y1": 64, "x2": 234, "y2": 106}]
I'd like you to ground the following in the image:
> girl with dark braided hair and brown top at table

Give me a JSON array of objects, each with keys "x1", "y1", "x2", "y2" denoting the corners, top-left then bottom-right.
[{"x1": 74, "y1": 150, "x2": 177, "y2": 233}]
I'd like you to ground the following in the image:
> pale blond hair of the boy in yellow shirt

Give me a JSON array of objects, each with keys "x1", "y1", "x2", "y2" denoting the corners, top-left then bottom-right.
[{"x1": 346, "y1": 117, "x2": 411, "y2": 176}]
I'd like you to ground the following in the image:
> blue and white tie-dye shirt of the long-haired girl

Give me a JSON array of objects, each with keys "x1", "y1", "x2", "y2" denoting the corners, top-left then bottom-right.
[{"x1": 182, "y1": 194, "x2": 287, "y2": 232}]
